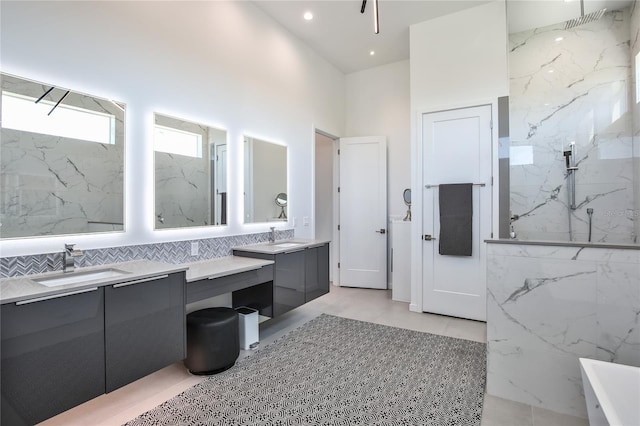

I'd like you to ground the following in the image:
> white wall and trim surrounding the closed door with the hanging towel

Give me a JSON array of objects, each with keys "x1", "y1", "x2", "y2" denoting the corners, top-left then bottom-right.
[{"x1": 409, "y1": 1, "x2": 509, "y2": 311}]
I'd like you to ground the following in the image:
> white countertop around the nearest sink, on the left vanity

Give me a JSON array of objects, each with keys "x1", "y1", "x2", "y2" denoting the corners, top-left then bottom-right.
[{"x1": 0, "y1": 260, "x2": 188, "y2": 304}]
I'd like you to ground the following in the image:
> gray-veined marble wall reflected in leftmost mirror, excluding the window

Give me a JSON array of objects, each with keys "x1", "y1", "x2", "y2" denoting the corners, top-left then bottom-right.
[{"x1": 0, "y1": 75, "x2": 125, "y2": 238}]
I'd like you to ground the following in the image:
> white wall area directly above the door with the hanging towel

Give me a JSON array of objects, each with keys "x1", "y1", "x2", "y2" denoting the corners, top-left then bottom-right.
[{"x1": 409, "y1": 1, "x2": 509, "y2": 112}]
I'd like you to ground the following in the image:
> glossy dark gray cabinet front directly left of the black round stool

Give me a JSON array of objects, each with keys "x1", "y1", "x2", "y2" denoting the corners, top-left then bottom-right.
[{"x1": 104, "y1": 272, "x2": 186, "y2": 392}]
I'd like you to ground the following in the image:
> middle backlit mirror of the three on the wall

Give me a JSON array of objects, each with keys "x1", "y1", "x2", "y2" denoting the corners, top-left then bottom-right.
[{"x1": 154, "y1": 114, "x2": 228, "y2": 229}]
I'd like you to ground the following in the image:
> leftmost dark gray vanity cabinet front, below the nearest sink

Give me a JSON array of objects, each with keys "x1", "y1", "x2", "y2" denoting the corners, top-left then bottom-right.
[{"x1": 0, "y1": 288, "x2": 105, "y2": 426}]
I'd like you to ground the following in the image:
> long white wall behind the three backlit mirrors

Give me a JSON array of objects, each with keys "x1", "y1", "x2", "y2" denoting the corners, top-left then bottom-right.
[{"x1": 0, "y1": 1, "x2": 345, "y2": 256}]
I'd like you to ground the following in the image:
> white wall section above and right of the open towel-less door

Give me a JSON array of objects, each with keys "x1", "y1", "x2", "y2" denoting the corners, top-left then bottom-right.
[{"x1": 344, "y1": 61, "x2": 411, "y2": 217}]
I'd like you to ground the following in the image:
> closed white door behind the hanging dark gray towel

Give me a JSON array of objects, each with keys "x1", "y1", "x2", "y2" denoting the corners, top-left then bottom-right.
[{"x1": 422, "y1": 105, "x2": 492, "y2": 321}]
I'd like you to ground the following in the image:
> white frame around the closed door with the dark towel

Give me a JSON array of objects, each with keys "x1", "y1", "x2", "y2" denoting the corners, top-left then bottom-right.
[{"x1": 409, "y1": 97, "x2": 500, "y2": 312}]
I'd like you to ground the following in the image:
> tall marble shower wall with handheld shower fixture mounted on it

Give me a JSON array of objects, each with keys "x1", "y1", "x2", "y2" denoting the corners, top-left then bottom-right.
[{"x1": 509, "y1": 9, "x2": 638, "y2": 243}]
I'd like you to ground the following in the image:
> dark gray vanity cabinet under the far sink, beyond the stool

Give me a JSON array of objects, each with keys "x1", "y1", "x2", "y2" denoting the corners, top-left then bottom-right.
[{"x1": 233, "y1": 244, "x2": 329, "y2": 317}]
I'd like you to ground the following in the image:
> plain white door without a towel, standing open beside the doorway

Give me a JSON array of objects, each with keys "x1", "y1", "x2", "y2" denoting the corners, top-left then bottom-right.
[{"x1": 339, "y1": 136, "x2": 387, "y2": 289}]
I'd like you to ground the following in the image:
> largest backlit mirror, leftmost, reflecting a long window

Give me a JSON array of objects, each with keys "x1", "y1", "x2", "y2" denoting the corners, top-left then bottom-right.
[{"x1": 0, "y1": 74, "x2": 125, "y2": 238}]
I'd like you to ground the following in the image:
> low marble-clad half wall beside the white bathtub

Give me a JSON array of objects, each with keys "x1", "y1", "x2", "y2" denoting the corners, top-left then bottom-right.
[{"x1": 487, "y1": 244, "x2": 640, "y2": 418}]
